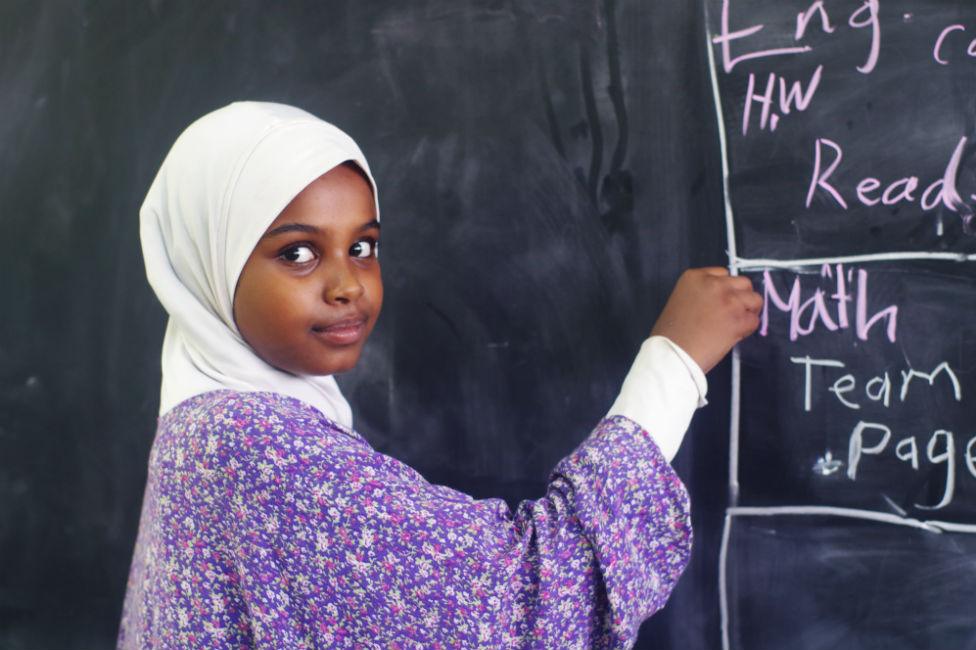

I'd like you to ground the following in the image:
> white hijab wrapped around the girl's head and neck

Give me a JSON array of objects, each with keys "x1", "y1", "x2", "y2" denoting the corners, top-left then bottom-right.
[{"x1": 139, "y1": 102, "x2": 379, "y2": 428}]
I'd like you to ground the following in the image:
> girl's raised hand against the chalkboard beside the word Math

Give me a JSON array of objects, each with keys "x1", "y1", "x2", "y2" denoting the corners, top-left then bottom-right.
[{"x1": 651, "y1": 266, "x2": 763, "y2": 372}]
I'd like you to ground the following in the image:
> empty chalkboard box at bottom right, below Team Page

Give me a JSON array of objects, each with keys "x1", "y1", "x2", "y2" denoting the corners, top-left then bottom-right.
[{"x1": 728, "y1": 515, "x2": 976, "y2": 650}]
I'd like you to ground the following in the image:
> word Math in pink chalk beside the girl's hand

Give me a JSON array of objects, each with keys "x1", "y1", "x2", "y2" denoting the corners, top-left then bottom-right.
[{"x1": 759, "y1": 264, "x2": 898, "y2": 343}]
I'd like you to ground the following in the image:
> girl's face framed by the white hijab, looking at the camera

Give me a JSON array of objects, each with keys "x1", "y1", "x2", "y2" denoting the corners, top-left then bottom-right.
[{"x1": 234, "y1": 164, "x2": 383, "y2": 375}]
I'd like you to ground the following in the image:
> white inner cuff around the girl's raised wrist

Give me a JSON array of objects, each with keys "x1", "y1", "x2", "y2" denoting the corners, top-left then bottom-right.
[{"x1": 607, "y1": 336, "x2": 708, "y2": 462}]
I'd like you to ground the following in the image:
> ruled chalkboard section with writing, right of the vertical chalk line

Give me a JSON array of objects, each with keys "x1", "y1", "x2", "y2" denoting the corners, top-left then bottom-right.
[{"x1": 706, "y1": 0, "x2": 976, "y2": 650}]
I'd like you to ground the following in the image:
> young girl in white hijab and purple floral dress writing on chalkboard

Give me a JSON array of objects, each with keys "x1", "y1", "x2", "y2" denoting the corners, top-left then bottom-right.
[{"x1": 118, "y1": 102, "x2": 761, "y2": 649}]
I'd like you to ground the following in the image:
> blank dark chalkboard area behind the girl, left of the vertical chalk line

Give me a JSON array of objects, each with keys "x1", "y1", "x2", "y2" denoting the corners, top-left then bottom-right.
[{"x1": 0, "y1": 0, "x2": 728, "y2": 649}]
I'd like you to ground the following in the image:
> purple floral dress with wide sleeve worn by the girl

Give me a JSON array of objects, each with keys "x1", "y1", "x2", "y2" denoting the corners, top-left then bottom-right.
[{"x1": 118, "y1": 391, "x2": 691, "y2": 650}]
